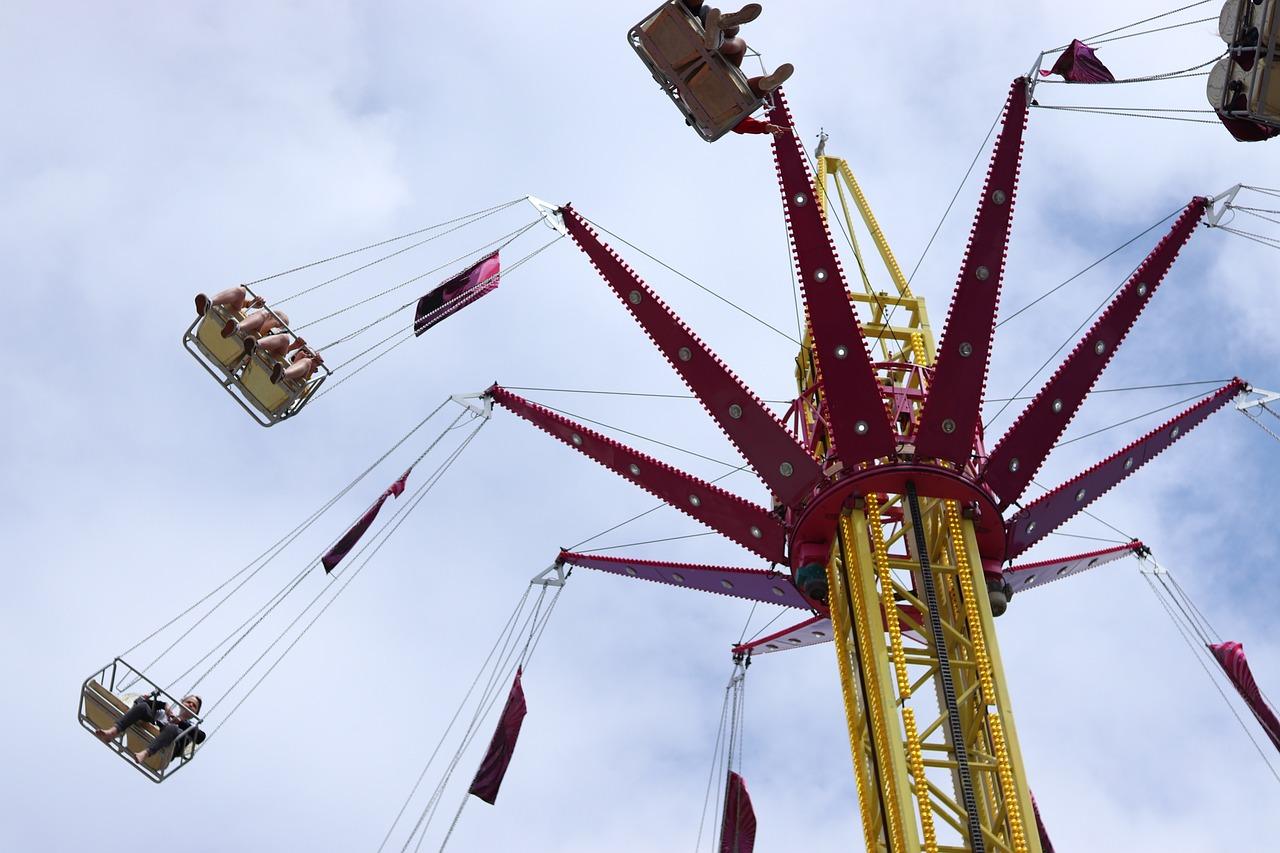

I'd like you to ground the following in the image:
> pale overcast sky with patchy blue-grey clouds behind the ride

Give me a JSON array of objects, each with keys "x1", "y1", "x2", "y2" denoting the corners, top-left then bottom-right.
[{"x1": 0, "y1": 0, "x2": 1280, "y2": 853}]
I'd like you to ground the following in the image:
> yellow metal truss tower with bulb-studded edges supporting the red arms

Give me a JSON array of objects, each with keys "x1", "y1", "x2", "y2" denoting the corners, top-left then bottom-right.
[{"x1": 796, "y1": 147, "x2": 1042, "y2": 853}]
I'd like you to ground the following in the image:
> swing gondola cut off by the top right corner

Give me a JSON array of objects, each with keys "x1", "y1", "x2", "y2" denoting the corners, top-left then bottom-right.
[{"x1": 1207, "y1": 0, "x2": 1280, "y2": 128}]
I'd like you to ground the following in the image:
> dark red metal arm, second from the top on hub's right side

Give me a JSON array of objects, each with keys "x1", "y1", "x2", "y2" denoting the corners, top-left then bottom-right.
[{"x1": 983, "y1": 197, "x2": 1208, "y2": 510}]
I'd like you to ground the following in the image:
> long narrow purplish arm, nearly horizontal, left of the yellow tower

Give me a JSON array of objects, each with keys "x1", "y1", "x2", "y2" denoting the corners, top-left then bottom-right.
[{"x1": 559, "y1": 551, "x2": 810, "y2": 610}]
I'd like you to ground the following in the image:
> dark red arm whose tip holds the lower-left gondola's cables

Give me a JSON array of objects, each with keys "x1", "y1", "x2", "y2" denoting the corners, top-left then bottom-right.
[{"x1": 488, "y1": 386, "x2": 786, "y2": 564}]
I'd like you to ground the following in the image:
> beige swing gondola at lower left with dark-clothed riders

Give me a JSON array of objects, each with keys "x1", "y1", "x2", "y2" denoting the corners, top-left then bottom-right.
[{"x1": 78, "y1": 658, "x2": 202, "y2": 783}]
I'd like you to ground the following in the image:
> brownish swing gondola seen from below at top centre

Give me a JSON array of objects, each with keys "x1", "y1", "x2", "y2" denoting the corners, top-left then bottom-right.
[{"x1": 627, "y1": 0, "x2": 764, "y2": 142}]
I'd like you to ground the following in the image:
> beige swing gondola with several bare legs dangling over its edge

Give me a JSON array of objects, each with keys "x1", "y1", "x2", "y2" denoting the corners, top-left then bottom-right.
[{"x1": 182, "y1": 287, "x2": 329, "y2": 427}]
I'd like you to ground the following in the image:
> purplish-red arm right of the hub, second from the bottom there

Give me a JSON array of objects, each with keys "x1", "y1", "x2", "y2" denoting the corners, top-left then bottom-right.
[{"x1": 1005, "y1": 379, "x2": 1248, "y2": 560}]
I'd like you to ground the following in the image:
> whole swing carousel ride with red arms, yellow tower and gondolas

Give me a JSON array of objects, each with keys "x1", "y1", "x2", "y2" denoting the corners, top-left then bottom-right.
[{"x1": 79, "y1": 0, "x2": 1280, "y2": 853}]
